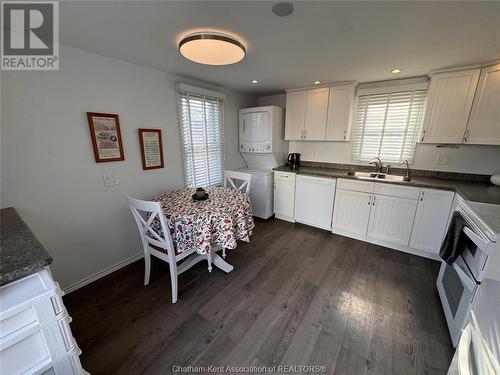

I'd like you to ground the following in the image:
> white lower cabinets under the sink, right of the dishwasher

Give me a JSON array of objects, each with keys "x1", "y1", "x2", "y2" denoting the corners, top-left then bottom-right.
[{"x1": 332, "y1": 179, "x2": 455, "y2": 259}]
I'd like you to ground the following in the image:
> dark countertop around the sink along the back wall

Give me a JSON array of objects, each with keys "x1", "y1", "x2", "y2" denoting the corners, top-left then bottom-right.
[{"x1": 274, "y1": 165, "x2": 500, "y2": 204}]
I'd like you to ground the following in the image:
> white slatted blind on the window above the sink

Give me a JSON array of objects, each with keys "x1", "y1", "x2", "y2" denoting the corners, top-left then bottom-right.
[{"x1": 352, "y1": 90, "x2": 427, "y2": 163}]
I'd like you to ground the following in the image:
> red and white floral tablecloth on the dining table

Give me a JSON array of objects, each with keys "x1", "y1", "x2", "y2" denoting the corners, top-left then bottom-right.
[{"x1": 153, "y1": 187, "x2": 255, "y2": 254}]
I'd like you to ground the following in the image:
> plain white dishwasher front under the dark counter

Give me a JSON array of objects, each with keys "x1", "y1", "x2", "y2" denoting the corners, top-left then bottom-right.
[{"x1": 295, "y1": 175, "x2": 335, "y2": 230}]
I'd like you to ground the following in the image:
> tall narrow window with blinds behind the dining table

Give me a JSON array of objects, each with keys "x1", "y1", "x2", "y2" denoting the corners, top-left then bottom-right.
[{"x1": 179, "y1": 84, "x2": 224, "y2": 187}]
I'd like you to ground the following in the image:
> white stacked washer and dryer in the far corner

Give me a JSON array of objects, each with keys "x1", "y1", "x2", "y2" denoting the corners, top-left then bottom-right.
[{"x1": 238, "y1": 106, "x2": 287, "y2": 219}]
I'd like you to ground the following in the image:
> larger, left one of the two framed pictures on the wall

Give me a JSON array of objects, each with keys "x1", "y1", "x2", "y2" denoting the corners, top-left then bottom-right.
[{"x1": 87, "y1": 112, "x2": 125, "y2": 163}]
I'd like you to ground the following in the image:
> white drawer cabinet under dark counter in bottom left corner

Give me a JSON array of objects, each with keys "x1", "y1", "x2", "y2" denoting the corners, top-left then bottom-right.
[{"x1": 0, "y1": 269, "x2": 87, "y2": 375}]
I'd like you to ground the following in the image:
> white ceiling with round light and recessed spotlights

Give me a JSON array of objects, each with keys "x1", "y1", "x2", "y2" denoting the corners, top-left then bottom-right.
[{"x1": 60, "y1": 1, "x2": 500, "y2": 95}]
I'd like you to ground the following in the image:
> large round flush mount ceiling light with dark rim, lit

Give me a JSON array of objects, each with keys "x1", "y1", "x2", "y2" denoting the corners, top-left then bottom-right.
[{"x1": 179, "y1": 32, "x2": 246, "y2": 65}]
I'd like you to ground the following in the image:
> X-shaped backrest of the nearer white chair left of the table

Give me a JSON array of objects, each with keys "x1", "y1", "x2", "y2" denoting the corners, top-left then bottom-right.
[{"x1": 125, "y1": 194, "x2": 174, "y2": 253}]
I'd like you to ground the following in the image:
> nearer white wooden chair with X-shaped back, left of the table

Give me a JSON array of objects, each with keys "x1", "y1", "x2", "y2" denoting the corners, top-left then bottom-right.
[{"x1": 125, "y1": 194, "x2": 212, "y2": 303}]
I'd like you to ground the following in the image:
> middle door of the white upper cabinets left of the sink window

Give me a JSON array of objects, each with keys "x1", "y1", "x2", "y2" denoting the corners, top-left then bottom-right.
[{"x1": 304, "y1": 87, "x2": 329, "y2": 141}]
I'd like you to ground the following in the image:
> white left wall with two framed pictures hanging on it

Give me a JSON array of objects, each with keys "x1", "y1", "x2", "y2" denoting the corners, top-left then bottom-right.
[{"x1": 1, "y1": 47, "x2": 257, "y2": 287}]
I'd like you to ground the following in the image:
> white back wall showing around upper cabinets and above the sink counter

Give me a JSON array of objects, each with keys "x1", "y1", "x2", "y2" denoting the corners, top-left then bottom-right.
[{"x1": 259, "y1": 94, "x2": 500, "y2": 174}]
